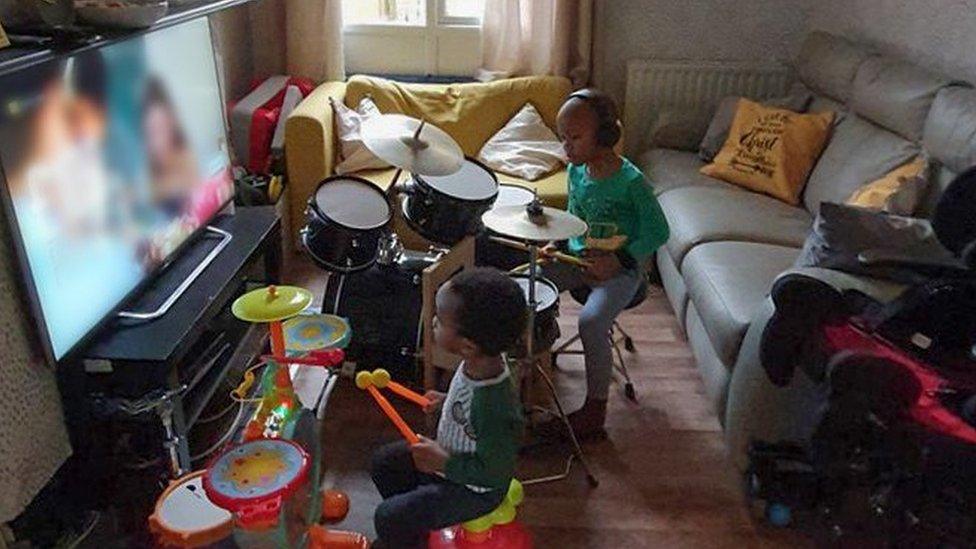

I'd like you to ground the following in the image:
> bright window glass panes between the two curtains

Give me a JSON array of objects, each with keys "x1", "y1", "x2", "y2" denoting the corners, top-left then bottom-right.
[{"x1": 342, "y1": 0, "x2": 485, "y2": 27}]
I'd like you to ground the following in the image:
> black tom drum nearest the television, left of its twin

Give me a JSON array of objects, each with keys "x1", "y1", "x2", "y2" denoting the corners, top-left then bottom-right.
[{"x1": 301, "y1": 175, "x2": 392, "y2": 273}]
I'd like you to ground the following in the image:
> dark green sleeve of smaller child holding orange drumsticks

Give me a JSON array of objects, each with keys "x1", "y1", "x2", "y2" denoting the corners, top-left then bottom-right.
[{"x1": 444, "y1": 383, "x2": 522, "y2": 489}]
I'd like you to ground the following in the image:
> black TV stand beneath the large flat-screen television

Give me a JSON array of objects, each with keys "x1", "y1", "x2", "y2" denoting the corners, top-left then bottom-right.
[{"x1": 59, "y1": 206, "x2": 281, "y2": 475}]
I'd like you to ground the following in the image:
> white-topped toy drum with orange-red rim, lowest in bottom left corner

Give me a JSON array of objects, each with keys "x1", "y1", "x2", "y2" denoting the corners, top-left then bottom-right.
[{"x1": 149, "y1": 471, "x2": 234, "y2": 547}]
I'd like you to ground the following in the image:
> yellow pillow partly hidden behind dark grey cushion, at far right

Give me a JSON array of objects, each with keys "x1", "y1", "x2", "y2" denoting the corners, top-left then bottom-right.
[{"x1": 847, "y1": 157, "x2": 928, "y2": 216}]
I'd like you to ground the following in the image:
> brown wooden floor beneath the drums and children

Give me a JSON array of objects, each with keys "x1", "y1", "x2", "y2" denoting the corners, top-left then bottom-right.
[{"x1": 288, "y1": 255, "x2": 810, "y2": 549}]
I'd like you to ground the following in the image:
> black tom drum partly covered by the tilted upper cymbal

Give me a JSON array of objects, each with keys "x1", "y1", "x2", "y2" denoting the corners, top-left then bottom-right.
[{"x1": 403, "y1": 158, "x2": 498, "y2": 246}]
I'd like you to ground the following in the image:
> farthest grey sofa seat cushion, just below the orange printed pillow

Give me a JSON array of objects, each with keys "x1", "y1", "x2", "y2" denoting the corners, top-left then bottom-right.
[{"x1": 658, "y1": 187, "x2": 813, "y2": 273}]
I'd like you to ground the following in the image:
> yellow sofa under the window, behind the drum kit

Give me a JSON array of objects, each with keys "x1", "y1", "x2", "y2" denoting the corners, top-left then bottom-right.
[{"x1": 285, "y1": 76, "x2": 571, "y2": 250}]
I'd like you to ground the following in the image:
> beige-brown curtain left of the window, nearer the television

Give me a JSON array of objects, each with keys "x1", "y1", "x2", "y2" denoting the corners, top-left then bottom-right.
[{"x1": 251, "y1": 0, "x2": 346, "y2": 82}]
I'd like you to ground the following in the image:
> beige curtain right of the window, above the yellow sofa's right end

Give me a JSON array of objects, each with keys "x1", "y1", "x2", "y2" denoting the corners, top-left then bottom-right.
[{"x1": 477, "y1": 0, "x2": 593, "y2": 86}]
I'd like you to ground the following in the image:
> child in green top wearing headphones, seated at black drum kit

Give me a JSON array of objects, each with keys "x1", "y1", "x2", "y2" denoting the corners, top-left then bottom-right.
[{"x1": 544, "y1": 88, "x2": 669, "y2": 439}]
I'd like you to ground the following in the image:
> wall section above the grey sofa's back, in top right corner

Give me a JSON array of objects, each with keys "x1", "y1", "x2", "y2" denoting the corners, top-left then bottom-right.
[{"x1": 809, "y1": 0, "x2": 976, "y2": 82}]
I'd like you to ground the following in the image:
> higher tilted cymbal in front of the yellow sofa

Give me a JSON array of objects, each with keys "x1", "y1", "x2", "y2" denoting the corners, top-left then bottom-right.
[{"x1": 362, "y1": 114, "x2": 464, "y2": 175}]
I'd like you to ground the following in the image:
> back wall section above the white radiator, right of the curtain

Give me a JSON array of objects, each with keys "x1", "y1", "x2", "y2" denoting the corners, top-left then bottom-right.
[{"x1": 593, "y1": 0, "x2": 812, "y2": 99}]
